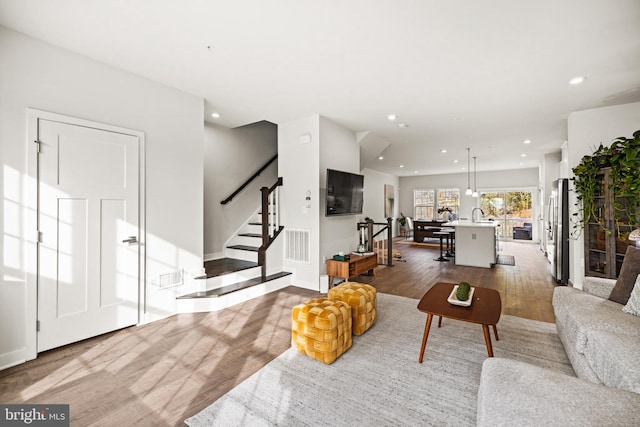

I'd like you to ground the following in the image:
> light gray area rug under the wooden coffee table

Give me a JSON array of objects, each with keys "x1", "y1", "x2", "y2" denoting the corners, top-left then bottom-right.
[{"x1": 185, "y1": 293, "x2": 575, "y2": 427}]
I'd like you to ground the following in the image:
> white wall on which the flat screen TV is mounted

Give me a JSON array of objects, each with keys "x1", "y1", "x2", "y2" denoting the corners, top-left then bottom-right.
[{"x1": 319, "y1": 117, "x2": 360, "y2": 274}]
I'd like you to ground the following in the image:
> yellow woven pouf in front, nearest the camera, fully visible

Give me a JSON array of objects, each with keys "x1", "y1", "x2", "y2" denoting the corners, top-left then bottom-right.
[{"x1": 291, "y1": 298, "x2": 352, "y2": 365}]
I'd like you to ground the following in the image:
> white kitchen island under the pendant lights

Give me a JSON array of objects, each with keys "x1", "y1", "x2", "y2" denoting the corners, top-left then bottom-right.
[{"x1": 444, "y1": 220, "x2": 500, "y2": 268}]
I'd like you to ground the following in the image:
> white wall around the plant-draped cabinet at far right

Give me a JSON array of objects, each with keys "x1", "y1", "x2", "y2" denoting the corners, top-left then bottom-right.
[{"x1": 567, "y1": 102, "x2": 640, "y2": 288}]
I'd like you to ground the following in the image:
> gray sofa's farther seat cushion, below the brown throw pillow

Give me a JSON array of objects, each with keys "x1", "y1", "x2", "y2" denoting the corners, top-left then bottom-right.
[{"x1": 553, "y1": 286, "x2": 640, "y2": 354}]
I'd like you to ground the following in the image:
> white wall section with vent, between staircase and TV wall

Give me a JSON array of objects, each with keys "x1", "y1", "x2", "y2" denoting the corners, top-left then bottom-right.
[{"x1": 278, "y1": 115, "x2": 320, "y2": 290}]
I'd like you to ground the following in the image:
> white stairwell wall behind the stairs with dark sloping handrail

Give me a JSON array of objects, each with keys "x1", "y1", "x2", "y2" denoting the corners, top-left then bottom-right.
[{"x1": 204, "y1": 121, "x2": 278, "y2": 260}]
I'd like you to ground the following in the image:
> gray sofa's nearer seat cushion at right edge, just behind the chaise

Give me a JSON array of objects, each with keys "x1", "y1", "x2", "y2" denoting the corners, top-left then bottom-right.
[{"x1": 584, "y1": 330, "x2": 640, "y2": 393}]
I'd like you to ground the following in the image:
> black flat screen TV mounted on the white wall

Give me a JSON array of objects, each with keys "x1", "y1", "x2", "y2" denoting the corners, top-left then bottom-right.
[{"x1": 326, "y1": 169, "x2": 364, "y2": 216}]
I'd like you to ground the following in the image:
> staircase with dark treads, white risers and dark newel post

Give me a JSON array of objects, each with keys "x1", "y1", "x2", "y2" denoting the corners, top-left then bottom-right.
[{"x1": 177, "y1": 178, "x2": 292, "y2": 312}]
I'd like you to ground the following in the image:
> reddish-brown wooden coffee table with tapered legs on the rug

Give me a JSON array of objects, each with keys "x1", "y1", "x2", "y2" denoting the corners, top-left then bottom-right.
[{"x1": 418, "y1": 283, "x2": 502, "y2": 363}]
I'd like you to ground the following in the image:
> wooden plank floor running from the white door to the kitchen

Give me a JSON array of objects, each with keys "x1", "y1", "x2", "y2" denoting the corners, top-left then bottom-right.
[{"x1": 0, "y1": 242, "x2": 555, "y2": 427}]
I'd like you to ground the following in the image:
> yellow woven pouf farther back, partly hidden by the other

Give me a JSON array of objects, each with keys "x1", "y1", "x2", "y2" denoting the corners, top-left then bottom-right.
[{"x1": 327, "y1": 282, "x2": 377, "y2": 335}]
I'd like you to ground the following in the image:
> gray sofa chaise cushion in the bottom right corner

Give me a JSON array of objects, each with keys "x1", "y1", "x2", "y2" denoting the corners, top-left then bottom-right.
[{"x1": 477, "y1": 357, "x2": 640, "y2": 427}]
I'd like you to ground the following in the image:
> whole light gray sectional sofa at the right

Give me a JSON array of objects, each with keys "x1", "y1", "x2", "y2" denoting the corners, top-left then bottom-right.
[{"x1": 477, "y1": 276, "x2": 640, "y2": 426}]
